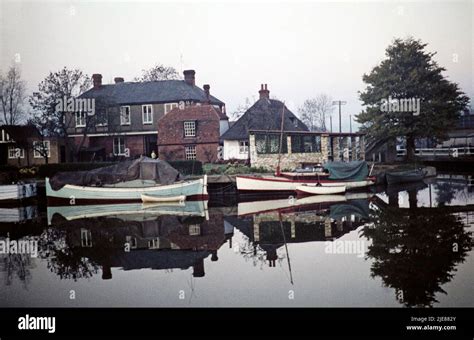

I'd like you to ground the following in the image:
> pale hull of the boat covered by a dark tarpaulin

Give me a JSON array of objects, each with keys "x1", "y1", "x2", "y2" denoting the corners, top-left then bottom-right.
[{"x1": 46, "y1": 176, "x2": 208, "y2": 204}]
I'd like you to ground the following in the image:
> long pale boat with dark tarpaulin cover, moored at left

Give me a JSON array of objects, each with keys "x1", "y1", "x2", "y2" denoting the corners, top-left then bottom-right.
[{"x1": 46, "y1": 157, "x2": 208, "y2": 205}]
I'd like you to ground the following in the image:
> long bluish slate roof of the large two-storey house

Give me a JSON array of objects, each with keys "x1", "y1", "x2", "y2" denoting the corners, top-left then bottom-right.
[{"x1": 79, "y1": 80, "x2": 224, "y2": 105}]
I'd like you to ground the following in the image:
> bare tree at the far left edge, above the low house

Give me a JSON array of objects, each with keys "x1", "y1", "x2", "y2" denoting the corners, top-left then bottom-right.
[{"x1": 0, "y1": 65, "x2": 26, "y2": 125}]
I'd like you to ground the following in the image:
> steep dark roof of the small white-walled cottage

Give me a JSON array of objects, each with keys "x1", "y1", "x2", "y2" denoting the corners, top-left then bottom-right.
[{"x1": 221, "y1": 98, "x2": 309, "y2": 140}]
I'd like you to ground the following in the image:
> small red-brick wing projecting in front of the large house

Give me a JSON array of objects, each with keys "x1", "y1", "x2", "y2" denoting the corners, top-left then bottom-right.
[{"x1": 158, "y1": 104, "x2": 227, "y2": 163}]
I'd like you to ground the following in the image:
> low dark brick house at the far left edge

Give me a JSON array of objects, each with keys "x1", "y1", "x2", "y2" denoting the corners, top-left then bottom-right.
[{"x1": 0, "y1": 125, "x2": 66, "y2": 167}]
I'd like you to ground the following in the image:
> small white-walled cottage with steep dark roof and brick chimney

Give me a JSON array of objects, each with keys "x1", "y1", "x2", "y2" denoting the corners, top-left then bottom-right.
[{"x1": 221, "y1": 84, "x2": 308, "y2": 160}]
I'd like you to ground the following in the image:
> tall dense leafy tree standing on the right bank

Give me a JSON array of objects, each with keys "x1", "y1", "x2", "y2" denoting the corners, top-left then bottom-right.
[{"x1": 357, "y1": 38, "x2": 469, "y2": 160}]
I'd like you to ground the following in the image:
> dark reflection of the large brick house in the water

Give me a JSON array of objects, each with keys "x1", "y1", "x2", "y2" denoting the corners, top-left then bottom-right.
[{"x1": 48, "y1": 203, "x2": 229, "y2": 280}]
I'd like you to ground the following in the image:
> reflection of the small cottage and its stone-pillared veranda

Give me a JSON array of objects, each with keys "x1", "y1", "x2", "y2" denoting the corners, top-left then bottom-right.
[{"x1": 225, "y1": 196, "x2": 369, "y2": 267}]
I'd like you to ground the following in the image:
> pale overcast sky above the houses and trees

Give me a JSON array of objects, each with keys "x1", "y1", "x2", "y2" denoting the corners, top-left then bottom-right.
[{"x1": 0, "y1": 0, "x2": 474, "y2": 131}]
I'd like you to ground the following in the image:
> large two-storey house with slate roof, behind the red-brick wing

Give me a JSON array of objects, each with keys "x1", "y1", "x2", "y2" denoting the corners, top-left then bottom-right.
[{"x1": 67, "y1": 70, "x2": 228, "y2": 161}]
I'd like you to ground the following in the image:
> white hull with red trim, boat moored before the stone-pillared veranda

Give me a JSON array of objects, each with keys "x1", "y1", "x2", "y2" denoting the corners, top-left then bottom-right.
[{"x1": 236, "y1": 176, "x2": 375, "y2": 192}]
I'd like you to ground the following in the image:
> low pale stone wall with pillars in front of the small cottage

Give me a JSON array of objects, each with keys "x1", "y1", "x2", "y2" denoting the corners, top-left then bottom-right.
[{"x1": 249, "y1": 134, "x2": 328, "y2": 170}]
